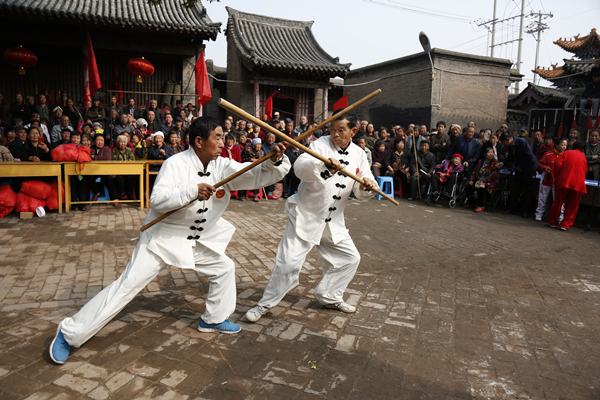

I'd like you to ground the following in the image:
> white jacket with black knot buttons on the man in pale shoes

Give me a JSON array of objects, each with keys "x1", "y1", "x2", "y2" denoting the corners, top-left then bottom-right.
[{"x1": 286, "y1": 136, "x2": 375, "y2": 244}]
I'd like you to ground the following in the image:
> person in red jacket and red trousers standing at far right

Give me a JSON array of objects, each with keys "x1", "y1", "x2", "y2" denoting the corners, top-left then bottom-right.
[{"x1": 548, "y1": 141, "x2": 587, "y2": 231}]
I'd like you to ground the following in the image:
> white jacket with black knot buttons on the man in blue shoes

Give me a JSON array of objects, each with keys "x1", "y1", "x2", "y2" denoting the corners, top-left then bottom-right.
[{"x1": 142, "y1": 148, "x2": 290, "y2": 268}]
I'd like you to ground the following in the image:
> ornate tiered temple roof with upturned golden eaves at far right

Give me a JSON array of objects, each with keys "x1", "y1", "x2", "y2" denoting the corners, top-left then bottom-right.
[{"x1": 533, "y1": 28, "x2": 600, "y2": 89}]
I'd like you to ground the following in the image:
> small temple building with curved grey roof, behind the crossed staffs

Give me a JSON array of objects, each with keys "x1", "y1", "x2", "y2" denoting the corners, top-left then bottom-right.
[{"x1": 225, "y1": 7, "x2": 350, "y2": 124}]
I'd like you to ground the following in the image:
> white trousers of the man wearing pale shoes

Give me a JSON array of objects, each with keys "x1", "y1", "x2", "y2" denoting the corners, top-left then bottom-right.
[{"x1": 258, "y1": 213, "x2": 360, "y2": 308}]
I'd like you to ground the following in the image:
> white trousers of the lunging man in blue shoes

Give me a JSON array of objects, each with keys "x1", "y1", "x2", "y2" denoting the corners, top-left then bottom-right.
[{"x1": 60, "y1": 234, "x2": 236, "y2": 347}]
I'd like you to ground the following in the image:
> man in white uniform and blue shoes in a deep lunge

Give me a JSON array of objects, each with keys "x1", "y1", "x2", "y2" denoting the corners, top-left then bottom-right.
[{"x1": 50, "y1": 117, "x2": 290, "y2": 364}]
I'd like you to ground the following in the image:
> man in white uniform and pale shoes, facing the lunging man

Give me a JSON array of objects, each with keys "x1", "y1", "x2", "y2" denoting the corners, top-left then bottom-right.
[{"x1": 246, "y1": 115, "x2": 378, "y2": 322}]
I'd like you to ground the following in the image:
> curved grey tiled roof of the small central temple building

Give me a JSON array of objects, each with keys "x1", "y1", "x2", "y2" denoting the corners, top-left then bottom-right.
[{"x1": 226, "y1": 7, "x2": 350, "y2": 77}]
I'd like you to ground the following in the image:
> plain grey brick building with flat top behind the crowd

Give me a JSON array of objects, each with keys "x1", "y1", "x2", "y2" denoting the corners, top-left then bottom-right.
[{"x1": 345, "y1": 49, "x2": 521, "y2": 129}]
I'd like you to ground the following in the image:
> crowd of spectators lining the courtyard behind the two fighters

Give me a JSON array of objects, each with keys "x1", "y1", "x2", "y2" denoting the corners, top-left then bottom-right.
[{"x1": 0, "y1": 90, "x2": 600, "y2": 228}]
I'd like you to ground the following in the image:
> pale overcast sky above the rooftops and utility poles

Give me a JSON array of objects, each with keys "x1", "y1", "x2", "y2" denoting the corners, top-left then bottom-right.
[{"x1": 203, "y1": 0, "x2": 600, "y2": 90}]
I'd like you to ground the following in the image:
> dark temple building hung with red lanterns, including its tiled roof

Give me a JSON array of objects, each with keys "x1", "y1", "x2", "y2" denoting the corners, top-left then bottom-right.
[{"x1": 0, "y1": 0, "x2": 221, "y2": 107}]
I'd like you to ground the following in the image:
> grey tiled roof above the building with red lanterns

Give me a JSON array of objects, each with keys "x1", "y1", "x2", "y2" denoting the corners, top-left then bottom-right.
[{"x1": 0, "y1": 0, "x2": 221, "y2": 40}]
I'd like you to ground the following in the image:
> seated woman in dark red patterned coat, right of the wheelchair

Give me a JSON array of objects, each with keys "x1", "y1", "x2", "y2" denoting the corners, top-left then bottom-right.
[{"x1": 465, "y1": 146, "x2": 500, "y2": 212}]
